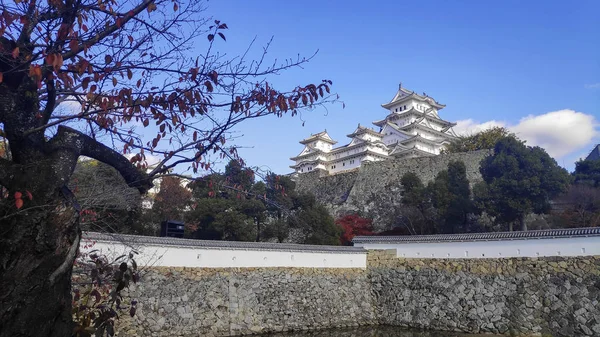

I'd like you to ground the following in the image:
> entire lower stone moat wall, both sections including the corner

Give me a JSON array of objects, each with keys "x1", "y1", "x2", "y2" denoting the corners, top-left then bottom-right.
[{"x1": 109, "y1": 251, "x2": 600, "y2": 337}]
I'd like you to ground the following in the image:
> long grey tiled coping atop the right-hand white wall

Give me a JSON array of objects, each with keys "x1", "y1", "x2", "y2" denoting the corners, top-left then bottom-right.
[{"x1": 352, "y1": 227, "x2": 600, "y2": 244}]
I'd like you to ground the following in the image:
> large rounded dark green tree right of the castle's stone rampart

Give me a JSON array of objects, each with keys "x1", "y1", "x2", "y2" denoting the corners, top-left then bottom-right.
[{"x1": 480, "y1": 137, "x2": 569, "y2": 231}]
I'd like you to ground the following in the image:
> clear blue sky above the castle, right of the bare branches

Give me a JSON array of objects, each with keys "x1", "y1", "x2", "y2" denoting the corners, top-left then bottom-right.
[{"x1": 207, "y1": 0, "x2": 600, "y2": 173}]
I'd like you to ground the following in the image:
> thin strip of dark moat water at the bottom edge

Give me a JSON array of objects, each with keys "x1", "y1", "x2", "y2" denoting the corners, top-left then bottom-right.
[{"x1": 263, "y1": 326, "x2": 499, "y2": 337}]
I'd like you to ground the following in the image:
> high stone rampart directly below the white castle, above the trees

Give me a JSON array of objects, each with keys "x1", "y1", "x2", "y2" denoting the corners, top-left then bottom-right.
[{"x1": 296, "y1": 150, "x2": 490, "y2": 231}]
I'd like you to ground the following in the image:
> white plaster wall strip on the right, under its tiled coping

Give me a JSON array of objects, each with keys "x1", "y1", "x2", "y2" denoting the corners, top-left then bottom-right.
[{"x1": 354, "y1": 237, "x2": 600, "y2": 259}]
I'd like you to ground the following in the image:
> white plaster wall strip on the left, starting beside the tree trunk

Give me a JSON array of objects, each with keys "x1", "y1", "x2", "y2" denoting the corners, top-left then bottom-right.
[{"x1": 81, "y1": 240, "x2": 367, "y2": 268}]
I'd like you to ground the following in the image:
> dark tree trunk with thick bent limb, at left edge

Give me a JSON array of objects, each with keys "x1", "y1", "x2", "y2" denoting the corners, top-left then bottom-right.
[{"x1": 0, "y1": 127, "x2": 152, "y2": 337}]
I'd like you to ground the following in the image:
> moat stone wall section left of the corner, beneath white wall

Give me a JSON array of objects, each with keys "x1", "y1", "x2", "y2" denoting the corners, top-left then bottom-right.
[{"x1": 118, "y1": 267, "x2": 376, "y2": 337}]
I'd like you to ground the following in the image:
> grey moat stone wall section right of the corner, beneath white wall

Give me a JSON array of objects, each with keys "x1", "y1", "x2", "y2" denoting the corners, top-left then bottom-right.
[{"x1": 369, "y1": 251, "x2": 600, "y2": 337}]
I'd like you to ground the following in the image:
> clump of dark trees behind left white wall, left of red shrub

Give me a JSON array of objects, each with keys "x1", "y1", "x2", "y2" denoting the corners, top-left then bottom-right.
[{"x1": 187, "y1": 161, "x2": 339, "y2": 244}]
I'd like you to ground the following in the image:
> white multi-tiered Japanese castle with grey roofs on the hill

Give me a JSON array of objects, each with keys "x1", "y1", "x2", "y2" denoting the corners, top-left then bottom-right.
[{"x1": 290, "y1": 85, "x2": 456, "y2": 174}]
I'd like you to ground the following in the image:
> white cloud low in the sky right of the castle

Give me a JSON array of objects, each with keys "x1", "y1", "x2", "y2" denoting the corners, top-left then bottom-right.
[{"x1": 454, "y1": 109, "x2": 600, "y2": 158}]
